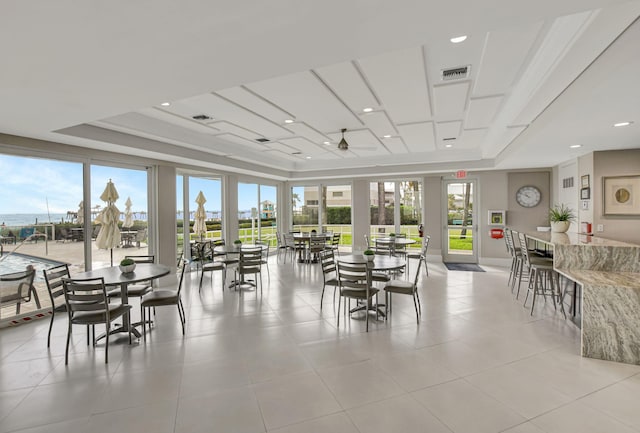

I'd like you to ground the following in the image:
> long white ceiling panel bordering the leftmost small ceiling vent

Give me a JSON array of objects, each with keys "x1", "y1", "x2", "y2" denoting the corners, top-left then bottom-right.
[{"x1": 168, "y1": 93, "x2": 292, "y2": 139}]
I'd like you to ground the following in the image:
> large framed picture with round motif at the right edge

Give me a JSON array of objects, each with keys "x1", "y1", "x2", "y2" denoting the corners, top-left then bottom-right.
[{"x1": 602, "y1": 175, "x2": 640, "y2": 215}]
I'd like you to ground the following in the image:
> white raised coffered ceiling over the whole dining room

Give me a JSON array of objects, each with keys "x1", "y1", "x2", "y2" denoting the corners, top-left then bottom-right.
[{"x1": 0, "y1": 1, "x2": 640, "y2": 178}]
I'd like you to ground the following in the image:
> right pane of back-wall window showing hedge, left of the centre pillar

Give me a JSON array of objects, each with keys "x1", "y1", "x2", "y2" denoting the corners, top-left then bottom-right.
[{"x1": 320, "y1": 185, "x2": 352, "y2": 250}]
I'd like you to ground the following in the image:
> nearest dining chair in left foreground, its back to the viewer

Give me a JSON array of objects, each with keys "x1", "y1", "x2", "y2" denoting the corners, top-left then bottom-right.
[{"x1": 62, "y1": 278, "x2": 131, "y2": 365}]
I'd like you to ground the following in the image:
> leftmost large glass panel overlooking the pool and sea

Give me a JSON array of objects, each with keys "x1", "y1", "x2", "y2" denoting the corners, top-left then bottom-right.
[{"x1": 0, "y1": 155, "x2": 85, "y2": 322}]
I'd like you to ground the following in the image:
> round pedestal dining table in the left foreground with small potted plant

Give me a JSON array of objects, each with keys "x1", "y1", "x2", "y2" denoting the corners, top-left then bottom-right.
[{"x1": 73, "y1": 263, "x2": 171, "y2": 339}]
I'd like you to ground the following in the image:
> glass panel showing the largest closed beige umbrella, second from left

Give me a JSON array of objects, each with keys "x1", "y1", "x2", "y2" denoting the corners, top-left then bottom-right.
[{"x1": 91, "y1": 165, "x2": 149, "y2": 269}]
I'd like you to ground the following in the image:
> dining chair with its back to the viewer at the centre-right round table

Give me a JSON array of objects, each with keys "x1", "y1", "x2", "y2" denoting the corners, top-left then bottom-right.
[{"x1": 336, "y1": 260, "x2": 379, "y2": 332}]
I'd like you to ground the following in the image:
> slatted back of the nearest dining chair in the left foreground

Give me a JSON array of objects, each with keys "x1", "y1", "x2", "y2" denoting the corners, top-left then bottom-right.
[{"x1": 62, "y1": 277, "x2": 110, "y2": 322}]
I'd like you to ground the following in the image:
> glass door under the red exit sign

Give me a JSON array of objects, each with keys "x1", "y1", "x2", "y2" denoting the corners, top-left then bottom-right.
[{"x1": 442, "y1": 179, "x2": 478, "y2": 263}]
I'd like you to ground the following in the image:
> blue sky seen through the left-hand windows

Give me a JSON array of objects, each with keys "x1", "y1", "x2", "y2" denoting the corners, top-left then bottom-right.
[{"x1": 0, "y1": 155, "x2": 276, "y2": 214}]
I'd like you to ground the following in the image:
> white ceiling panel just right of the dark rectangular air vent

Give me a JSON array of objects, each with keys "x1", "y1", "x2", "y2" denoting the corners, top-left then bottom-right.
[{"x1": 473, "y1": 22, "x2": 543, "y2": 96}]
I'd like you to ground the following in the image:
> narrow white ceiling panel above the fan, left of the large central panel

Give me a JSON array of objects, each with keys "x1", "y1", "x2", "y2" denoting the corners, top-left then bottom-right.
[{"x1": 315, "y1": 62, "x2": 379, "y2": 113}]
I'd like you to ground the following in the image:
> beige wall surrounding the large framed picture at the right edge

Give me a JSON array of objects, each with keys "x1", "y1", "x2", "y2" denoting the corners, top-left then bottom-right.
[{"x1": 591, "y1": 149, "x2": 640, "y2": 243}]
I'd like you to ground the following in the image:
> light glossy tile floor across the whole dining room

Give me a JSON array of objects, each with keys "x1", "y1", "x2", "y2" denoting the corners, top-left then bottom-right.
[{"x1": 0, "y1": 258, "x2": 640, "y2": 433}]
